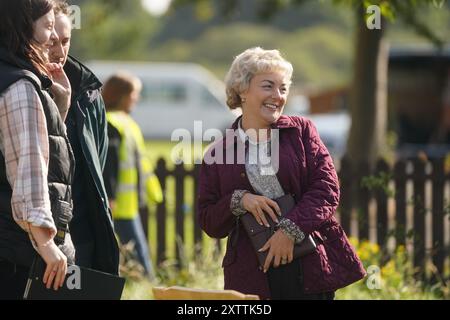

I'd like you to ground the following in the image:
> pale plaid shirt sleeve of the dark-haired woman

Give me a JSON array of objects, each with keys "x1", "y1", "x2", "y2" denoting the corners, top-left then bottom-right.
[{"x1": 0, "y1": 80, "x2": 56, "y2": 238}]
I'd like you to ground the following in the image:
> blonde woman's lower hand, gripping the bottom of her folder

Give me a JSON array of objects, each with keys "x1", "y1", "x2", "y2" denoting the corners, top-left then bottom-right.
[{"x1": 259, "y1": 230, "x2": 294, "y2": 272}]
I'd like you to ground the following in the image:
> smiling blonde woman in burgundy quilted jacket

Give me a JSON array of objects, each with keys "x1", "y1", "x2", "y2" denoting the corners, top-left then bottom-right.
[{"x1": 198, "y1": 48, "x2": 365, "y2": 299}]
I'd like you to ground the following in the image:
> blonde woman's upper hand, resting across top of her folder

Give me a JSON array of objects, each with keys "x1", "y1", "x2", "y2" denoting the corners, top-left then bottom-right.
[{"x1": 242, "y1": 192, "x2": 281, "y2": 227}]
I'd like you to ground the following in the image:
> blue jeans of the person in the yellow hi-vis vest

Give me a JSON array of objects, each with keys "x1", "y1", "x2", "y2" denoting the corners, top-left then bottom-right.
[{"x1": 114, "y1": 215, "x2": 155, "y2": 279}]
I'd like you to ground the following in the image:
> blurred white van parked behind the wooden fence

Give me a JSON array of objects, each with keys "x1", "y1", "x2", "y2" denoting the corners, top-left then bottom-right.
[{"x1": 88, "y1": 61, "x2": 237, "y2": 139}]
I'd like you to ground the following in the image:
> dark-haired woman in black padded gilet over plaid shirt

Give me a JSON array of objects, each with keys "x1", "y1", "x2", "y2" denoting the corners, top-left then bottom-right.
[{"x1": 0, "y1": 0, "x2": 75, "y2": 299}]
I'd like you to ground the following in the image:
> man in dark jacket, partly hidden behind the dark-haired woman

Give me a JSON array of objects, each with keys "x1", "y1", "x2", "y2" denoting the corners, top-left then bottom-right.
[{"x1": 50, "y1": 2, "x2": 119, "y2": 274}]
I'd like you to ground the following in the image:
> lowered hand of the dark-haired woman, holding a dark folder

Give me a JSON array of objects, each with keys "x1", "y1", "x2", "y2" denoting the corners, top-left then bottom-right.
[{"x1": 30, "y1": 226, "x2": 67, "y2": 290}]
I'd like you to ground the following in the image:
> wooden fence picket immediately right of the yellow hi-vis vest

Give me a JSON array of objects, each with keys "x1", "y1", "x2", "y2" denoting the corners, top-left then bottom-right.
[{"x1": 155, "y1": 158, "x2": 168, "y2": 265}]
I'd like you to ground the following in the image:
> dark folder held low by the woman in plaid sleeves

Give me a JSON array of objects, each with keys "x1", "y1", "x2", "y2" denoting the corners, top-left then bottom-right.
[{"x1": 24, "y1": 256, "x2": 125, "y2": 300}]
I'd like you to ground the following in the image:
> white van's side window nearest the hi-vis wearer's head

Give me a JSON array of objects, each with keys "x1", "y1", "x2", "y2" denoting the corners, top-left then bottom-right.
[{"x1": 141, "y1": 80, "x2": 187, "y2": 106}]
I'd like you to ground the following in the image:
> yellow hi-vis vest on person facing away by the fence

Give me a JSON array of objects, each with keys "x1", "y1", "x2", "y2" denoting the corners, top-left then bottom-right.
[{"x1": 106, "y1": 111, "x2": 163, "y2": 219}]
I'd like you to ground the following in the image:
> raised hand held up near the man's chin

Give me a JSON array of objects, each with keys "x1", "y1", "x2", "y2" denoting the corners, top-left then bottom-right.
[{"x1": 47, "y1": 63, "x2": 72, "y2": 120}]
